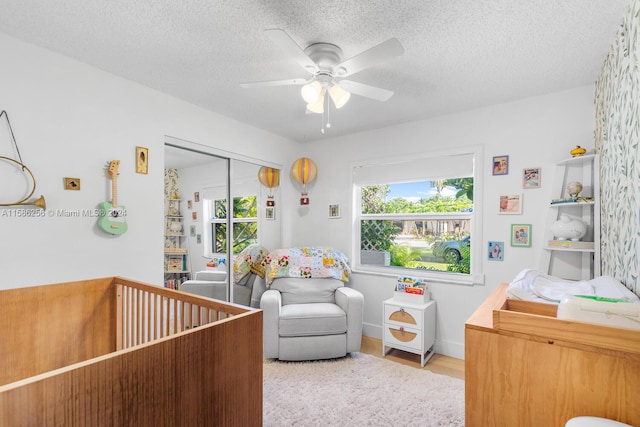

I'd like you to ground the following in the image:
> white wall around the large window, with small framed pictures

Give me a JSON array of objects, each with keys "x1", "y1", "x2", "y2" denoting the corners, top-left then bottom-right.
[{"x1": 291, "y1": 86, "x2": 594, "y2": 358}]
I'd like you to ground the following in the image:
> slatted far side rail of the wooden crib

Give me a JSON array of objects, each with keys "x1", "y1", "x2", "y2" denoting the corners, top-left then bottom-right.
[{"x1": 113, "y1": 277, "x2": 248, "y2": 350}]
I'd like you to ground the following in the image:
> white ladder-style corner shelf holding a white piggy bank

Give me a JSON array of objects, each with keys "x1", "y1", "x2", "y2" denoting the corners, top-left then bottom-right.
[{"x1": 541, "y1": 154, "x2": 600, "y2": 280}]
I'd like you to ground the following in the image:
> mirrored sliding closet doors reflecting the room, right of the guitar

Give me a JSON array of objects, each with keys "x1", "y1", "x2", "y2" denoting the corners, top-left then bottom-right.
[{"x1": 164, "y1": 138, "x2": 281, "y2": 307}]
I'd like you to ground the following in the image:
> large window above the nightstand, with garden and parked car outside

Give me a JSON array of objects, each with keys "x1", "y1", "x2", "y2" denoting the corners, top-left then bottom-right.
[{"x1": 353, "y1": 148, "x2": 482, "y2": 283}]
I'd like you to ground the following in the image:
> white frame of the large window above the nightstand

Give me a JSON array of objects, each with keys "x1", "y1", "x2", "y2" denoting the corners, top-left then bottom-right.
[{"x1": 350, "y1": 146, "x2": 484, "y2": 285}]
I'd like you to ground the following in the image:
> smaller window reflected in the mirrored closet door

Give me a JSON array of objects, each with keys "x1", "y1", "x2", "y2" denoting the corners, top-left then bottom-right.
[{"x1": 209, "y1": 195, "x2": 258, "y2": 254}]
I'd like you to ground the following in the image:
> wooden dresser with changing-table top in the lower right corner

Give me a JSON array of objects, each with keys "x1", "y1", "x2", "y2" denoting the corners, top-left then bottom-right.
[{"x1": 465, "y1": 283, "x2": 640, "y2": 427}]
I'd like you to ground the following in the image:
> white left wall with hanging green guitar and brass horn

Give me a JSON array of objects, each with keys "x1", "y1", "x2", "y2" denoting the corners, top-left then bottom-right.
[{"x1": 0, "y1": 34, "x2": 298, "y2": 288}]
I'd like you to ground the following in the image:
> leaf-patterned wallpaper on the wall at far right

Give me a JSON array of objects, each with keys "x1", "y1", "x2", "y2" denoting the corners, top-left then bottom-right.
[{"x1": 595, "y1": 0, "x2": 640, "y2": 293}]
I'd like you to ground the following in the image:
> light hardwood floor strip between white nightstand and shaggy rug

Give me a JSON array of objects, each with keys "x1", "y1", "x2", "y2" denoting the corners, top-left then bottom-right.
[{"x1": 360, "y1": 336, "x2": 464, "y2": 379}]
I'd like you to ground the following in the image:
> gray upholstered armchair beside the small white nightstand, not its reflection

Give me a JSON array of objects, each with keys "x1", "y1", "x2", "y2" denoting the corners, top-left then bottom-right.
[{"x1": 260, "y1": 278, "x2": 364, "y2": 360}]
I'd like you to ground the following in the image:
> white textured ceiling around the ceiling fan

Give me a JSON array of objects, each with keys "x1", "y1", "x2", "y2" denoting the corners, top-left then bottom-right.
[{"x1": 0, "y1": 0, "x2": 631, "y2": 142}]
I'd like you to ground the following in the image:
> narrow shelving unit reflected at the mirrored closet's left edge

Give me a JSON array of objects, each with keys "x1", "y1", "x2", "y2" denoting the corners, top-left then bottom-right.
[{"x1": 164, "y1": 199, "x2": 190, "y2": 288}]
